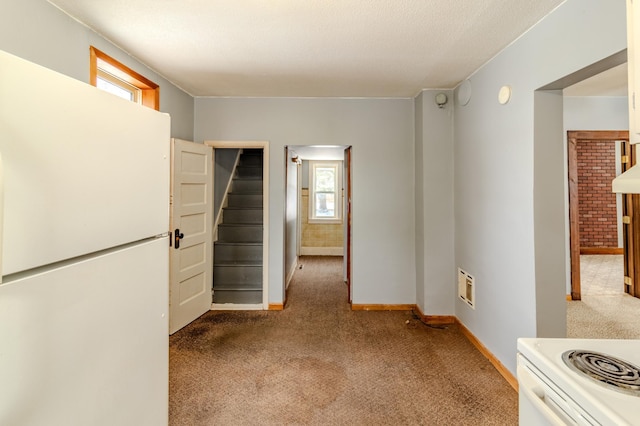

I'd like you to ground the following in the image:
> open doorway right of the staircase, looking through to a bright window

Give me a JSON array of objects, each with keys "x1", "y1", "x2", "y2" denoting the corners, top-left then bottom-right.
[{"x1": 283, "y1": 145, "x2": 353, "y2": 303}]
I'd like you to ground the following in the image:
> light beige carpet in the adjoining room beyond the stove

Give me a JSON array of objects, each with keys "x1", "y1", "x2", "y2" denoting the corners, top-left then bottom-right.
[{"x1": 567, "y1": 255, "x2": 640, "y2": 339}]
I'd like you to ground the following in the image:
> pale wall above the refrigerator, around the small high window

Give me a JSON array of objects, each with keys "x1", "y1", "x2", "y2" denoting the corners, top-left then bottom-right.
[{"x1": 0, "y1": 0, "x2": 193, "y2": 140}]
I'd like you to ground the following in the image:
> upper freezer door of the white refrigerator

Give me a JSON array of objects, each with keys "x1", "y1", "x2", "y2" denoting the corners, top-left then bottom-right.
[{"x1": 0, "y1": 51, "x2": 170, "y2": 275}]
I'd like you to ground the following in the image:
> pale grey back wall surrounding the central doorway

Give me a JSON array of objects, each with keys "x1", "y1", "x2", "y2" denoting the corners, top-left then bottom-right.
[{"x1": 195, "y1": 98, "x2": 416, "y2": 304}]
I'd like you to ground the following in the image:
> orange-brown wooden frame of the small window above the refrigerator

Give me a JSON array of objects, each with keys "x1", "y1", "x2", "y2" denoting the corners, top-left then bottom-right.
[{"x1": 89, "y1": 46, "x2": 160, "y2": 111}]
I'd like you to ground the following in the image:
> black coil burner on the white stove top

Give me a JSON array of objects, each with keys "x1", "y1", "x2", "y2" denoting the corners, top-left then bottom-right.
[{"x1": 562, "y1": 350, "x2": 640, "y2": 396}]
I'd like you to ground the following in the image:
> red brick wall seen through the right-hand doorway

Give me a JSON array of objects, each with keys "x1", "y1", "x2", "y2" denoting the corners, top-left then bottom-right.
[{"x1": 577, "y1": 140, "x2": 618, "y2": 248}]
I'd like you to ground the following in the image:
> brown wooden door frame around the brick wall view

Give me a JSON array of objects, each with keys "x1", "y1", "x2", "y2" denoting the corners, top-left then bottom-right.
[{"x1": 567, "y1": 130, "x2": 629, "y2": 300}]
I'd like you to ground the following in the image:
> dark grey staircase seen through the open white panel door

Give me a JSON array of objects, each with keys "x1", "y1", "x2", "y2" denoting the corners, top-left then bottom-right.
[{"x1": 213, "y1": 149, "x2": 262, "y2": 304}]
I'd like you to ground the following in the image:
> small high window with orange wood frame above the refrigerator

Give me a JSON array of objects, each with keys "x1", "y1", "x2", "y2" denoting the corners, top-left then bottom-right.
[{"x1": 89, "y1": 46, "x2": 160, "y2": 110}]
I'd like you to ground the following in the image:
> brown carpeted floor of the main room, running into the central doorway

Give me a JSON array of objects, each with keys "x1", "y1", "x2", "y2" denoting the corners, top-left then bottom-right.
[{"x1": 169, "y1": 257, "x2": 518, "y2": 426}]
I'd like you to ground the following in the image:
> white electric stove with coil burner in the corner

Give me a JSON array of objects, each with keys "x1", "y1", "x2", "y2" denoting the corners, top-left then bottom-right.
[{"x1": 518, "y1": 338, "x2": 640, "y2": 426}]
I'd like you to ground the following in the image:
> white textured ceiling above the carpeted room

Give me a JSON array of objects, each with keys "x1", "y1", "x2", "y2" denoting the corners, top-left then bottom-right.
[{"x1": 49, "y1": 0, "x2": 564, "y2": 97}]
